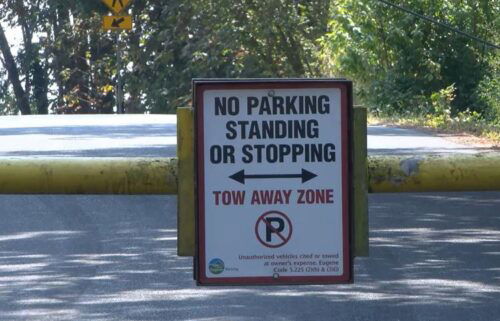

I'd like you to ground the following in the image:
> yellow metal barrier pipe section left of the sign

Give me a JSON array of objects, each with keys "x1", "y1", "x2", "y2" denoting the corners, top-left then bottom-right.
[{"x1": 0, "y1": 158, "x2": 177, "y2": 194}]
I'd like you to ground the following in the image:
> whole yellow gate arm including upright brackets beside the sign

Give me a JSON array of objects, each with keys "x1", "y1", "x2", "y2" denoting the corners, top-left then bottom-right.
[{"x1": 0, "y1": 108, "x2": 500, "y2": 256}]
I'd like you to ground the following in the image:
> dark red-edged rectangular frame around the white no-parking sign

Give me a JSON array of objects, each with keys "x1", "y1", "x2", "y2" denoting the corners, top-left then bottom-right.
[{"x1": 193, "y1": 79, "x2": 353, "y2": 285}]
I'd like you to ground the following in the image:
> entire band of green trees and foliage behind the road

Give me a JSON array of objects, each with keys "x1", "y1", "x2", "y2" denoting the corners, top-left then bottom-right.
[{"x1": 0, "y1": 0, "x2": 500, "y2": 123}]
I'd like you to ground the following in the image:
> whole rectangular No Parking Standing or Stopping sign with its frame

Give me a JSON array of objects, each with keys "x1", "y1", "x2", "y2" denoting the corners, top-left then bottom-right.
[{"x1": 193, "y1": 80, "x2": 352, "y2": 285}]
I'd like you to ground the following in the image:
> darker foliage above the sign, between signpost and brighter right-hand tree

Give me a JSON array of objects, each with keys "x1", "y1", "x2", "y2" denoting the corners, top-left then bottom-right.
[{"x1": 122, "y1": 0, "x2": 329, "y2": 112}]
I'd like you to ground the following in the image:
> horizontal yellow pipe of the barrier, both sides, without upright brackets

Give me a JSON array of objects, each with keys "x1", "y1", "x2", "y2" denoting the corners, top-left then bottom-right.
[{"x1": 0, "y1": 153, "x2": 500, "y2": 195}]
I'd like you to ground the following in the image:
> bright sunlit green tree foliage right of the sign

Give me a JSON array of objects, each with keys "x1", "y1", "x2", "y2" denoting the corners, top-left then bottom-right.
[{"x1": 320, "y1": 0, "x2": 500, "y2": 119}]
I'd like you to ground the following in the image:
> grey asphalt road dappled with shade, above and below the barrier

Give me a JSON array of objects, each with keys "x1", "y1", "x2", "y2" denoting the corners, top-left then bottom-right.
[{"x1": 0, "y1": 115, "x2": 500, "y2": 321}]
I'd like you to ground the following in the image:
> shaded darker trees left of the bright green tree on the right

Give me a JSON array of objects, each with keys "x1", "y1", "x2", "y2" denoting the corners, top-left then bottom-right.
[{"x1": 0, "y1": 0, "x2": 331, "y2": 113}]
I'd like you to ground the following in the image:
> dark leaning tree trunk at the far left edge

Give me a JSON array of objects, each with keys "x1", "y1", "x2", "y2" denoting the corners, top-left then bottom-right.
[{"x1": 0, "y1": 24, "x2": 31, "y2": 115}]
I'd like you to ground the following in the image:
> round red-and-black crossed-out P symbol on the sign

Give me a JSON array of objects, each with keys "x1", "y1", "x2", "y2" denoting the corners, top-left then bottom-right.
[{"x1": 255, "y1": 211, "x2": 292, "y2": 248}]
